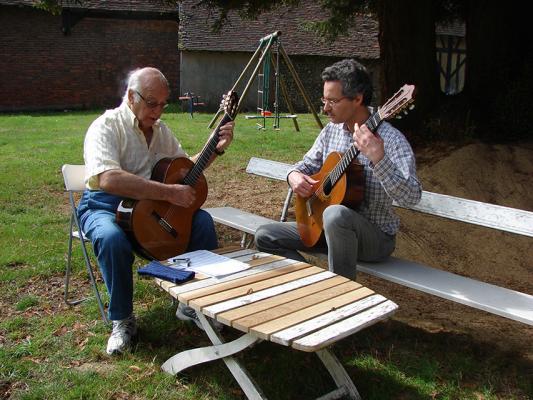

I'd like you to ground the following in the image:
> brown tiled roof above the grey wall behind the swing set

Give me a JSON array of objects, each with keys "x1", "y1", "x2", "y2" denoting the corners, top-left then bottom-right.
[{"x1": 179, "y1": 0, "x2": 379, "y2": 59}]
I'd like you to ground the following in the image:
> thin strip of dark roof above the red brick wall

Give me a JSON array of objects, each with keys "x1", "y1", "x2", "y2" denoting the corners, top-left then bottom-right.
[{"x1": 0, "y1": 0, "x2": 178, "y2": 13}]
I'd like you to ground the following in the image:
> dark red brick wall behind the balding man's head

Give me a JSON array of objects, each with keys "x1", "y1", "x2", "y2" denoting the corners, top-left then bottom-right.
[{"x1": 0, "y1": 6, "x2": 179, "y2": 111}]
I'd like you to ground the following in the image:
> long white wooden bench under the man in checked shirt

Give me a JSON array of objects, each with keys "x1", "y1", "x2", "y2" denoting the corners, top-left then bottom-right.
[{"x1": 206, "y1": 157, "x2": 533, "y2": 325}]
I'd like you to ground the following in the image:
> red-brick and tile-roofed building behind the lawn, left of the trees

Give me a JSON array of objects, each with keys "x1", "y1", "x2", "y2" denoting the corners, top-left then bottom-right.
[{"x1": 0, "y1": 0, "x2": 379, "y2": 112}]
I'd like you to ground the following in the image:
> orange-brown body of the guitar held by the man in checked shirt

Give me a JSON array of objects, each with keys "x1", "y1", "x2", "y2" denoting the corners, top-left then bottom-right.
[{"x1": 294, "y1": 152, "x2": 364, "y2": 247}]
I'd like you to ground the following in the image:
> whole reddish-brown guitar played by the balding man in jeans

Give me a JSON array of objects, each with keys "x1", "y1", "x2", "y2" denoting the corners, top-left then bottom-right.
[{"x1": 116, "y1": 91, "x2": 238, "y2": 260}]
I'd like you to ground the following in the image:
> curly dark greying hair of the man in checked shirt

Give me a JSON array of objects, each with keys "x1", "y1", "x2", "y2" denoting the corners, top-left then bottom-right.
[{"x1": 322, "y1": 59, "x2": 373, "y2": 106}]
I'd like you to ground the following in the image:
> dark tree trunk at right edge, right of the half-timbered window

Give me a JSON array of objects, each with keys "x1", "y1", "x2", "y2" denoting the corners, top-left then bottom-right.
[{"x1": 465, "y1": 0, "x2": 533, "y2": 141}]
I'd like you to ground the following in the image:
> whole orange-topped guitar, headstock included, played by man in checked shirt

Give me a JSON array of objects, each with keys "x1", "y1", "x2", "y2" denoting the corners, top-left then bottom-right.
[{"x1": 294, "y1": 85, "x2": 415, "y2": 247}]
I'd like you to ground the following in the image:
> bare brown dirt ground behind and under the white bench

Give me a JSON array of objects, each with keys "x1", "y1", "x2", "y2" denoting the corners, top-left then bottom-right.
[{"x1": 206, "y1": 142, "x2": 533, "y2": 360}]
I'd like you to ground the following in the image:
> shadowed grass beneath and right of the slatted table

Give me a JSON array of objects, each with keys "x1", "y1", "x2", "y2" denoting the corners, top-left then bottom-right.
[{"x1": 137, "y1": 305, "x2": 533, "y2": 400}]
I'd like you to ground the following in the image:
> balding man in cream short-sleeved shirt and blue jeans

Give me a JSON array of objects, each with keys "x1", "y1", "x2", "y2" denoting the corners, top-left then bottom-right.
[{"x1": 78, "y1": 68, "x2": 234, "y2": 354}]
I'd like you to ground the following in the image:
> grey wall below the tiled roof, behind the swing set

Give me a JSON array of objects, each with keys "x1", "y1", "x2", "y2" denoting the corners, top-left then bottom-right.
[{"x1": 180, "y1": 51, "x2": 379, "y2": 113}]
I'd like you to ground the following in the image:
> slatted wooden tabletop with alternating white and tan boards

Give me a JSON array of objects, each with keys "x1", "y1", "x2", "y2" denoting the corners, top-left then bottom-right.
[{"x1": 156, "y1": 248, "x2": 398, "y2": 352}]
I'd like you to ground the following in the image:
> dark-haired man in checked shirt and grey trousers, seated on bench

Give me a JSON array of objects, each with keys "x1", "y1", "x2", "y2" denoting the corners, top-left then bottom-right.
[{"x1": 255, "y1": 60, "x2": 422, "y2": 279}]
